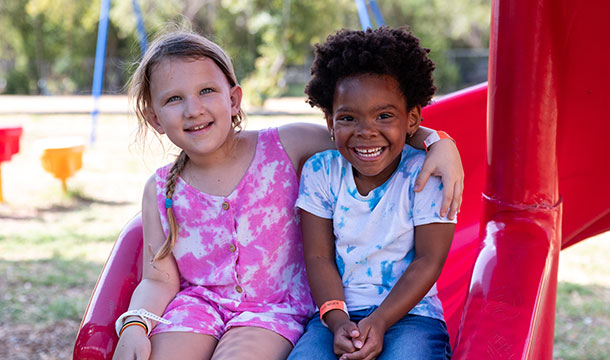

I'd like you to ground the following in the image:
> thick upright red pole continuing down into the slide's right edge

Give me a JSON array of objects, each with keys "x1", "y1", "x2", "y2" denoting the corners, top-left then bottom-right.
[{"x1": 454, "y1": 0, "x2": 561, "y2": 359}]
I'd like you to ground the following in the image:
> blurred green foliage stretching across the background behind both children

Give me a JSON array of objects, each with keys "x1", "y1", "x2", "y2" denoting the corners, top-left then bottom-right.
[{"x1": 0, "y1": 0, "x2": 490, "y2": 95}]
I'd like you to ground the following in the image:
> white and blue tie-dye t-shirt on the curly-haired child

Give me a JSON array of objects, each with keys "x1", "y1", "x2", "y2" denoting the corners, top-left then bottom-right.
[{"x1": 296, "y1": 145, "x2": 455, "y2": 320}]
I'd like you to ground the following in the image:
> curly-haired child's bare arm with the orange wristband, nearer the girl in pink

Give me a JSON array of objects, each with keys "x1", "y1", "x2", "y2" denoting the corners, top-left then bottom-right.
[{"x1": 301, "y1": 210, "x2": 359, "y2": 355}]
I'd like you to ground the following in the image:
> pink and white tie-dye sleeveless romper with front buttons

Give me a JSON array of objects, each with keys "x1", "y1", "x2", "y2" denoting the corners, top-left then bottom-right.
[{"x1": 152, "y1": 129, "x2": 315, "y2": 344}]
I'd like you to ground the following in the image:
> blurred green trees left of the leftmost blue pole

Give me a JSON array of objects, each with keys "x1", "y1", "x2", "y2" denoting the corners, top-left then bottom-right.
[{"x1": 0, "y1": 0, "x2": 99, "y2": 94}]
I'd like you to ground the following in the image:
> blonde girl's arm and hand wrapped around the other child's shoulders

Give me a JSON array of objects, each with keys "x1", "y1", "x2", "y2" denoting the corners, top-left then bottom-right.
[{"x1": 278, "y1": 123, "x2": 464, "y2": 219}]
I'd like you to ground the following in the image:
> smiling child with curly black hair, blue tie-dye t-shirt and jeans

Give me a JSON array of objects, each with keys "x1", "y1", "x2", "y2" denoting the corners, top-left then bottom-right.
[{"x1": 289, "y1": 27, "x2": 455, "y2": 360}]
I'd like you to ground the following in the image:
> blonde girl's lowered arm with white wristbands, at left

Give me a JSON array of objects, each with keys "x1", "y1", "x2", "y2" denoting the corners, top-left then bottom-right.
[{"x1": 113, "y1": 176, "x2": 180, "y2": 359}]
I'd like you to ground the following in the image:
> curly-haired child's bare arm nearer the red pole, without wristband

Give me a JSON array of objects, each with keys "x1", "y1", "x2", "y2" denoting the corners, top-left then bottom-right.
[{"x1": 341, "y1": 223, "x2": 455, "y2": 360}]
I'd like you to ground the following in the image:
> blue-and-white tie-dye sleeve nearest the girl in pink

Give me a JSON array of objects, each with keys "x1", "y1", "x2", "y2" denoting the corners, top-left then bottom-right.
[{"x1": 295, "y1": 153, "x2": 335, "y2": 219}]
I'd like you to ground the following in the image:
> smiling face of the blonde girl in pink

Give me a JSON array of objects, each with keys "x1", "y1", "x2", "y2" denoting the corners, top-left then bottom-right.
[{"x1": 147, "y1": 58, "x2": 241, "y2": 158}]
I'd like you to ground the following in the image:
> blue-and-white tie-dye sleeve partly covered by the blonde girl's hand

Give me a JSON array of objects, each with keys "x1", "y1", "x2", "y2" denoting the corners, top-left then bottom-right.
[{"x1": 413, "y1": 176, "x2": 456, "y2": 226}]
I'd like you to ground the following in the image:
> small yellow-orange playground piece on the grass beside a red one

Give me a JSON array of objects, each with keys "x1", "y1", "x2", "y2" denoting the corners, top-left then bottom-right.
[{"x1": 40, "y1": 138, "x2": 85, "y2": 193}]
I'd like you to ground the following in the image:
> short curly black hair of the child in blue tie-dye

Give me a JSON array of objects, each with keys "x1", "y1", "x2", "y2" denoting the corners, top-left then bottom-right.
[{"x1": 305, "y1": 26, "x2": 436, "y2": 115}]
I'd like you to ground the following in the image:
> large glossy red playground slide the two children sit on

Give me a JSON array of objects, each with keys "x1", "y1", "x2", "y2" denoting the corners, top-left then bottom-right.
[{"x1": 74, "y1": 0, "x2": 610, "y2": 360}]
